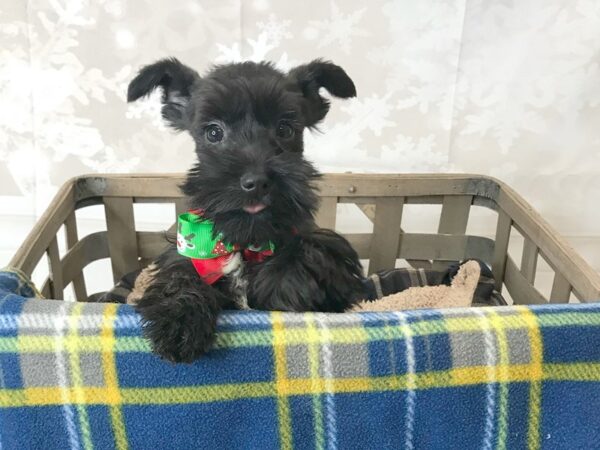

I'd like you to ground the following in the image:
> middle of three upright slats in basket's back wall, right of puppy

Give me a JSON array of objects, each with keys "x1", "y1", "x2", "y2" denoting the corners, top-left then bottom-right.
[{"x1": 369, "y1": 197, "x2": 404, "y2": 274}]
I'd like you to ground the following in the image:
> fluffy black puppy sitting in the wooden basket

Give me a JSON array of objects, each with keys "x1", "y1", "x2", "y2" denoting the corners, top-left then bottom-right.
[{"x1": 127, "y1": 59, "x2": 364, "y2": 362}]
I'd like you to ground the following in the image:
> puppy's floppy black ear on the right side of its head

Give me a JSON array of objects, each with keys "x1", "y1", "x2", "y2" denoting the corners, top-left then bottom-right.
[{"x1": 288, "y1": 59, "x2": 356, "y2": 127}]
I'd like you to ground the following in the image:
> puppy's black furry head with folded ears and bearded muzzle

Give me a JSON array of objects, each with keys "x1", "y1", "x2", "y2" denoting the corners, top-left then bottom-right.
[{"x1": 127, "y1": 59, "x2": 356, "y2": 245}]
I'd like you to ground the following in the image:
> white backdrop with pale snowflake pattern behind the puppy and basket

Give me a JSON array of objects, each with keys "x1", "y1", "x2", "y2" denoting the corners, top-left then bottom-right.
[{"x1": 0, "y1": 0, "x2": 600, "y2": 292}]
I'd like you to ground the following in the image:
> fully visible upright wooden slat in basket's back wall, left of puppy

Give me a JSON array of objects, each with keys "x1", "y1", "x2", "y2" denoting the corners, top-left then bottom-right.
[{"x1": 104, "y1": 197, "x2": 139, "y2": 283}]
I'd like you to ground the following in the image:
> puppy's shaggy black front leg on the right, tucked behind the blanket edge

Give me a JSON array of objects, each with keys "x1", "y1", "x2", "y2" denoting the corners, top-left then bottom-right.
[{"x1": 248, "y1": 230, "x2": 365, "y2": 312}]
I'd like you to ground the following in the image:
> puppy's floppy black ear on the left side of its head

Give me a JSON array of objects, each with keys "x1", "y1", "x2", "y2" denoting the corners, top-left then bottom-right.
[{"x1": 127, "y1": 58, "x2": 200, "y2": 130}]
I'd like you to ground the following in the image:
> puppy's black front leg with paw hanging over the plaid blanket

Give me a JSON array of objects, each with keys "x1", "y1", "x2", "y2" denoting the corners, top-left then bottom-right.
[{"x1": 135, "y1": 250, "x2": 226, "y2": 363}]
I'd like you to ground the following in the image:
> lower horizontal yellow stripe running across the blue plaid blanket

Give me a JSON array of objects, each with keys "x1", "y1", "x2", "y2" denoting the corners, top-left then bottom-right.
[{"x1": 0, "y1": 363, "x2": 600, "y2": 407}]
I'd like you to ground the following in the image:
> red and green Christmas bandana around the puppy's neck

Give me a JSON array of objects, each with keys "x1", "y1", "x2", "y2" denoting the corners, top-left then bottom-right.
[{"x1": 177, "y1": 211, "x2": 275, "y2": 284}]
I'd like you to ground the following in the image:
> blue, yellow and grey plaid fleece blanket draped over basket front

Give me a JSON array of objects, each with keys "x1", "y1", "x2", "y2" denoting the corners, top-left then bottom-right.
[{"x1": 0, "y1": 272, "x2": 600, "y2": 449}]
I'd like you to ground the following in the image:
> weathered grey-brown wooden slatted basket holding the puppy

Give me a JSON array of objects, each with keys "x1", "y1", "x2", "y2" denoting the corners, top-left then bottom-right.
[{"x1": 10, "y1": 174, "x2": 600, "y2": 304}]
